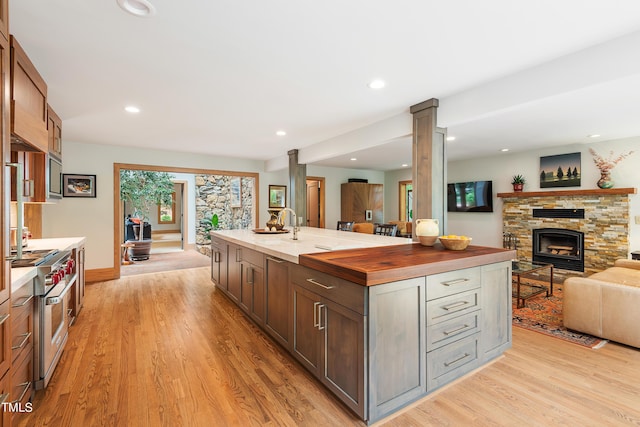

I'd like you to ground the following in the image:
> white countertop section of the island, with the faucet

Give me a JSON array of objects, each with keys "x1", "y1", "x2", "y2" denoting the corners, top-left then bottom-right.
[{"x1": 211, "y1": 227, "x2": 413, "y2": 264}]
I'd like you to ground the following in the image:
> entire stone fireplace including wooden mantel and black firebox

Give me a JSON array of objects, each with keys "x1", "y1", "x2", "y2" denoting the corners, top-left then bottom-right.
[{"x1": 498, "y1": 188, "x2": 636, "y2": 280}]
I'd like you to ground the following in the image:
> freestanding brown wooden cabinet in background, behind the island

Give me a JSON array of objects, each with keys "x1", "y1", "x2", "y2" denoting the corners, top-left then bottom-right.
[{"x1": 340, "y1": 182, "x2": 384, "y2": 223}]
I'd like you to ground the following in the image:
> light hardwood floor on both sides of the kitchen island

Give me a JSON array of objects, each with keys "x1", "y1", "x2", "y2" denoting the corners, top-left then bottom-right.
[{"x1": 13, "y1": 267, "x2": 640, "y2": 427}]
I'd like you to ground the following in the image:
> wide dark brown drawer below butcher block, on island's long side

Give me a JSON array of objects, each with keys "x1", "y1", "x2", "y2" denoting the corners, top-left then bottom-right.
[{"x1": 291, "y1": 265, "x2": 366, "y2": 314}]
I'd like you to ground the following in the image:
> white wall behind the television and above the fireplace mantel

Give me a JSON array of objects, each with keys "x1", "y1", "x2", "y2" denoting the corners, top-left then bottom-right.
[{"x1": 442, "y1": 137, "x2": 640, "y2": 251}]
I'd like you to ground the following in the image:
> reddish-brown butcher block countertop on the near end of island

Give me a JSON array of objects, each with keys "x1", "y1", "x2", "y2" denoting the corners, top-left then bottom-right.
[{"x1": 299, "y1": 243, "x2": 516, "y2": 286}]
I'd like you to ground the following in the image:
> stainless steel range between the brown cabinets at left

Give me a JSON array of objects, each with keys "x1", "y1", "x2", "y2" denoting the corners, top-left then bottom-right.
[{"x1": 34, "y1": 251, "x2": 77, "y2": 390}]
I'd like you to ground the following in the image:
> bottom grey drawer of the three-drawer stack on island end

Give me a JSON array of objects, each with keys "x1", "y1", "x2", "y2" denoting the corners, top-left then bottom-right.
[{"x1": 427, "y1": 333, "x2": 480, "y2": 391}]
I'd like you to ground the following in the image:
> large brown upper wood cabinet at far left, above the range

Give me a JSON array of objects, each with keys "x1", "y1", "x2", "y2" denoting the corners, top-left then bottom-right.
[{"x1": 11, "y1": 36, "x2": 49, "y2": 152}]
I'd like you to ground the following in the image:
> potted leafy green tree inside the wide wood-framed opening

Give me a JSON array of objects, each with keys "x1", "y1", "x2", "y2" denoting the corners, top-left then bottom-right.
[{"x1": 120, "y1": 169, "x2": 173, "y2": 259}]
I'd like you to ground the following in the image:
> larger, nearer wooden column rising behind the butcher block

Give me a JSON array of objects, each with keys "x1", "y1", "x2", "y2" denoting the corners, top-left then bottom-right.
[{"x1": 409, "y1": 98, "x2": 447, "y2": 240}]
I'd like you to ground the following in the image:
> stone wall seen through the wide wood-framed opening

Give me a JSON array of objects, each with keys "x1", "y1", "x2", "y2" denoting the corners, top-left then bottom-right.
[{"x1": 195, "y1": 175, "x2": 256, "y2": 256}]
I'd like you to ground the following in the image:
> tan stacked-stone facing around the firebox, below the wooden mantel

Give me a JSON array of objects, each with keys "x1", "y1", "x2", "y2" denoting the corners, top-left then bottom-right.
[{"x1": 502, "y1": 194, "x2": 630, "y2": 281}]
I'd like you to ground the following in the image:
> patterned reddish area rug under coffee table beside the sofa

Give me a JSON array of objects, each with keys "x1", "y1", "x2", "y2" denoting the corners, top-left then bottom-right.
[{"x1": 513, "y1": 283, "x2": 607, "y2": 348}]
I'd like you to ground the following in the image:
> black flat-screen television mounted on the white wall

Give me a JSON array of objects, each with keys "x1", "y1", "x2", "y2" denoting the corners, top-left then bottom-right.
[{"x1": 447, "y1": 181, "x2": 493, "y2": 212}]
